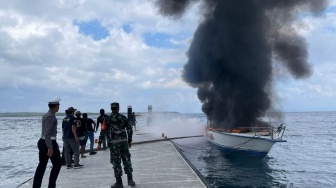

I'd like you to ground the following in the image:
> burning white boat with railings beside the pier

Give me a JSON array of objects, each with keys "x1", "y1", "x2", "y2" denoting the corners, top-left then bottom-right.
[{"x1": 206, "y1": 121, "x2": 287, "y2": 158}]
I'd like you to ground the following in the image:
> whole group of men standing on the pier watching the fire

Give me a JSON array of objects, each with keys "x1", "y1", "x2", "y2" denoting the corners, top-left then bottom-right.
[{"x1": 33, "y1": 98, "x2": 135, "y2": 188}]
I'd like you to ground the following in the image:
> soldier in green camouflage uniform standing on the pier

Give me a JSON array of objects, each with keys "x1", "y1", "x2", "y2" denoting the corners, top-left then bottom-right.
[{"x1": 107, "y1": 102, "x2": 135, "y2": 188}]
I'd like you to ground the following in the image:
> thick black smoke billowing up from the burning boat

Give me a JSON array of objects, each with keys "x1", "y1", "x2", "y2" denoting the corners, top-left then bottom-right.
[{"x1": 156, "y1": 0, "x2": 327, "y2": 128}]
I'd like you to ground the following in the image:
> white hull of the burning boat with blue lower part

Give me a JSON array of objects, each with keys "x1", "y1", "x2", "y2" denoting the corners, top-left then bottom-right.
[{"x1": 207, "y1": 130, "x2": 286, "y2": 157}]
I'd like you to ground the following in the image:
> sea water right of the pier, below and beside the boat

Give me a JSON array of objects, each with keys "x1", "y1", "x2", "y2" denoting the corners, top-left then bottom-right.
[{"x1": 174, "y1": 112, "x2": 336, "y2": 188}]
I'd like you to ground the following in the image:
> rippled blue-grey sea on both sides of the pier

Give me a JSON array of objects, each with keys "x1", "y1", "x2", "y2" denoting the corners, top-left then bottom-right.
[{"x1": 0, "y1": 112, "x2": 336, "y2": 188}]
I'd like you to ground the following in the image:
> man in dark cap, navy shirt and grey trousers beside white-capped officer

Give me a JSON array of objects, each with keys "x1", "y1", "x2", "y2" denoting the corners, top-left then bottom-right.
[{"x1": 62, "y1": 107, "x2": 83, "y2": 169}]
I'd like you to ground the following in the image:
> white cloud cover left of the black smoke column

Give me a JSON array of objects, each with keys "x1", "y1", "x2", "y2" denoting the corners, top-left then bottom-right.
[{"x1": 0, "y1": 0, "x2": 199, "y2": 111}]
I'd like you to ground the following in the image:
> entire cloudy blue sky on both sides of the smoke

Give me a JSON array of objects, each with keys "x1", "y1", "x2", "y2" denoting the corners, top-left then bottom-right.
[{"x1": 0, "y1": 0, "x2": 336, "y2": 113}]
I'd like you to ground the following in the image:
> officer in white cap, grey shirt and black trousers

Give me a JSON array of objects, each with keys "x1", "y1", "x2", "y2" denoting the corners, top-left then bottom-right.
[{"x1": 33, "y1": 98, "x2": 62, "y2": 188}]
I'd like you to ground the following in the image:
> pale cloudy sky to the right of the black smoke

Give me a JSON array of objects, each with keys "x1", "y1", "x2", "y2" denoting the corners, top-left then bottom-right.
[{"x1": 277, "y1": 0, "x2": 336, "y2": 111}]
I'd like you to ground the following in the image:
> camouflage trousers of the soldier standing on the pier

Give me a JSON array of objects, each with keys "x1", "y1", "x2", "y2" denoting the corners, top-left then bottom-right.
[{"x1": 110, "y1": 142, "x2": 133, "y2": 177}]
